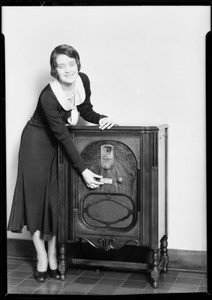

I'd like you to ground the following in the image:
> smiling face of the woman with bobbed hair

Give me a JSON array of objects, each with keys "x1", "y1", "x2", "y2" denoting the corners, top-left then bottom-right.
[{"x1": 56, "y1": 54, "x2": 78, "y2": 85}]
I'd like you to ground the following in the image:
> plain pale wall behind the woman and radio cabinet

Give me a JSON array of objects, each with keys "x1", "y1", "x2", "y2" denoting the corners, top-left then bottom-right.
[{"x1": 2, "y1": 6, "x2": 210, "y2": 251}]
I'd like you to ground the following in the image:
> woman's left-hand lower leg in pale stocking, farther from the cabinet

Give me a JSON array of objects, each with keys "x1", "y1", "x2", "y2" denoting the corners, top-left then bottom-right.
[{"x1": 32, "y1": 230, "x2": 48, "y2": 272}]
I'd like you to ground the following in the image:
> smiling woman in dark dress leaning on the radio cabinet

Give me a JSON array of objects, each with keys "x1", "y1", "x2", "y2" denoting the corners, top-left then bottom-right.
[{"x1": 8, "y1": 45, "x2": 114, "y2": 281}]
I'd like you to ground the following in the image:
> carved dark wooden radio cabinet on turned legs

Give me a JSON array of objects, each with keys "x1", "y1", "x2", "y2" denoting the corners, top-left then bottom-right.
[{"x1": 58, "y1": 125, "x2": 168, "y2": 288}]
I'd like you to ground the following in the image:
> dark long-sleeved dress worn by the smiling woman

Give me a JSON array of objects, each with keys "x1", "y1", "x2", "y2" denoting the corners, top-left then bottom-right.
[{"x1": 8, "y1": 72, "x2": 104, "y2": 234}]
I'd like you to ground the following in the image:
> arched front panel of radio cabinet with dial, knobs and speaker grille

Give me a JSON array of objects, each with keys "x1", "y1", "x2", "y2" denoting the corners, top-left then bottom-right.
[{"x1": 74, "y1": 139, "x2": 140, "y2": 245}]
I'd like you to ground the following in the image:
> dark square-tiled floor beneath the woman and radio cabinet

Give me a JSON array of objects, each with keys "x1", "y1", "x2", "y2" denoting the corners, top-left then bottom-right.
[{"x1": 7, "y1": 258, "x2": 207, "y2": 295}]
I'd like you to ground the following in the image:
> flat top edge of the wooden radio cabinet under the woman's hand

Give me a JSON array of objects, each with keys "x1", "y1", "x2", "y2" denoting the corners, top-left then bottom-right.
[{"x1": 67, "y1": 124, "x2": 168, "y2": 132}]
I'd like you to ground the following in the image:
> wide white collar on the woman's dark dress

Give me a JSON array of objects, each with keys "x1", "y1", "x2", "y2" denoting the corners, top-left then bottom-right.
[{"x1": 49, "y1": 75, "x2": 85, "y2": 111}]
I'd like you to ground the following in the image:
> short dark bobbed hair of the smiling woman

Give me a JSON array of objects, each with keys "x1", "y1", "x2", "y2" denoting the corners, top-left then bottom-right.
[{"x1": 50, "y1": 44, "x2": 81, "y2": 78}]
